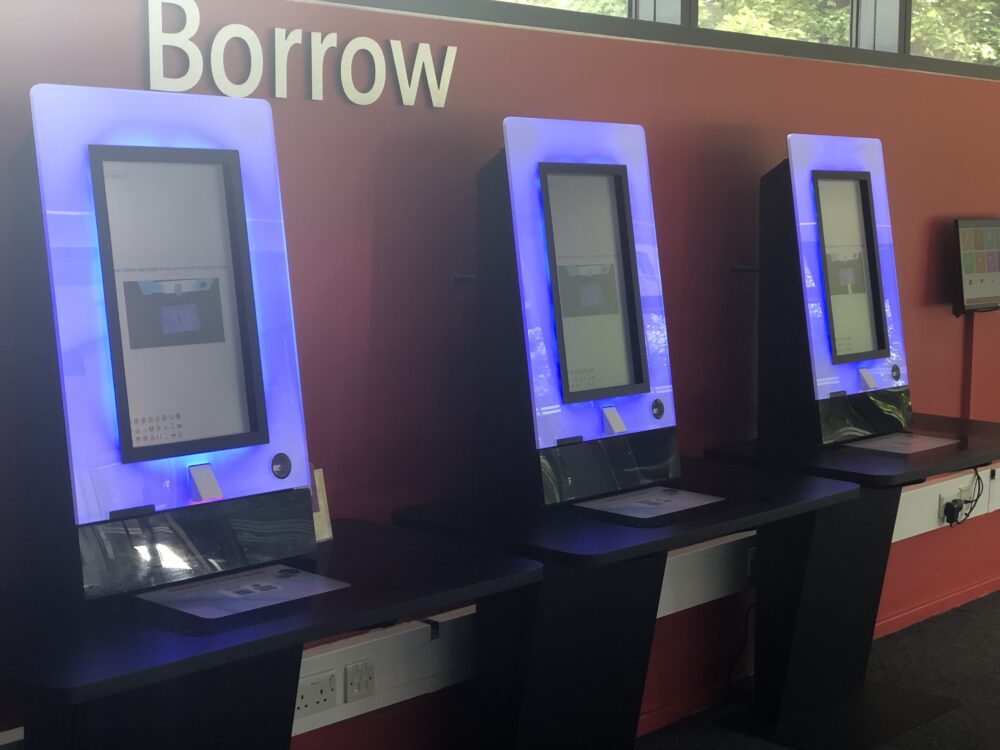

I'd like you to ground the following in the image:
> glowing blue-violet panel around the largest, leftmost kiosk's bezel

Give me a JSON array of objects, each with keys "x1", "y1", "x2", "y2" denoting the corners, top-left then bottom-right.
[{"x1": 31, "y1": 85, "x2": 310, "y2": 525}]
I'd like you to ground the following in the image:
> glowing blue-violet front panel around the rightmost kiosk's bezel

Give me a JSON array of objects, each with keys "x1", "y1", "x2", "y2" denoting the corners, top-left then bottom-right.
[{"x1": 788, "y1": 134, "x2": 909, "y2": 400}]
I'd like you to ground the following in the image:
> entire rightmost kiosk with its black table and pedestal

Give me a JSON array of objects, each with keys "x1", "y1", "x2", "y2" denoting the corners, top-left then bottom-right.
[{"x1": 708, "y1": 135, "x2": 1000, "y2": 748}]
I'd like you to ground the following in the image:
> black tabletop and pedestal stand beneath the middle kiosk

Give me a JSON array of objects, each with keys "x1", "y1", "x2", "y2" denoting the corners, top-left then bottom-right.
[{"x1": 393, "y1": 459, "x2": 858, "y2": 750}]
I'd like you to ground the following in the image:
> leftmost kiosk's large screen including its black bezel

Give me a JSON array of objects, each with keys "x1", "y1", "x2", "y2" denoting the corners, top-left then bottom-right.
[{"x1": 90, "y1": 146, "x2": 267, "y2": 462}]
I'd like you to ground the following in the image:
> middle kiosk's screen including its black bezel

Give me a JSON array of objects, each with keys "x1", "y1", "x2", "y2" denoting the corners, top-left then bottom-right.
[{"x1": 540, "y1": 164, "x2": 649, "y2": 403}]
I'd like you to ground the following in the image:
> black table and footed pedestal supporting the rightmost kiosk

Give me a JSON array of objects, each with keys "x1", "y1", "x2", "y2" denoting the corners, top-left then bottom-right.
[{"x1": 708, "y1": 414, "x2": 1000, "y2": 750}]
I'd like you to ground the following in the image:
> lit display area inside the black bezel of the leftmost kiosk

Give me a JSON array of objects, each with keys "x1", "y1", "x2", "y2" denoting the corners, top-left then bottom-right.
[{"x1": 104, "y1": 161, "x2": 250, "y2": 448}]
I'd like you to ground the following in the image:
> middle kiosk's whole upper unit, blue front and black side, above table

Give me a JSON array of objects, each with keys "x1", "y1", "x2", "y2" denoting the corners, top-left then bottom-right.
[{"x1": 478, "y1": 118, "x2": 679, "y2": 504}]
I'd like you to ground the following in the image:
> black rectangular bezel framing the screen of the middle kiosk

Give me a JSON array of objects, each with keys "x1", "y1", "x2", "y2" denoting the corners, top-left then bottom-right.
[{"x1": 538, "y1": 162, "x2": 650, "y2": 404}]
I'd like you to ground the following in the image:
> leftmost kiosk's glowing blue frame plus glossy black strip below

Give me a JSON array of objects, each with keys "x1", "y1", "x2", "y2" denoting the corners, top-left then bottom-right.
[{"x1": 31, "y1": 84, "x2": 315, "y2": 598}]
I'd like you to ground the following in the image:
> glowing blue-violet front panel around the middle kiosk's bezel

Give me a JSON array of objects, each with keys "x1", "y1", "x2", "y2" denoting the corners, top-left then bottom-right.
[{"x1": 504, "y1": 117, "x2": 677, "y2": 449}]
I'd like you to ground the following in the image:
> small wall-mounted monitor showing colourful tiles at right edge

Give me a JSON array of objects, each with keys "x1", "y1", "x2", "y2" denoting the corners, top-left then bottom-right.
[{"x1": 955, "y1": 219, "x2": 1000, "y2": 314}]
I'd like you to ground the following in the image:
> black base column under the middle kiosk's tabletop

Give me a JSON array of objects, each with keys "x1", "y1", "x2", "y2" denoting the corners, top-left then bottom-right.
[{"x1": 477, "y1": 553, "x2": 666, "y2": 750}]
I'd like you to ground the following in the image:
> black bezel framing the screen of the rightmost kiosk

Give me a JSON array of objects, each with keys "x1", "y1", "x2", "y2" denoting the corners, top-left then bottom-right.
[{"x1": 812, "y1": 171, "x2": 889, "y2": 365}]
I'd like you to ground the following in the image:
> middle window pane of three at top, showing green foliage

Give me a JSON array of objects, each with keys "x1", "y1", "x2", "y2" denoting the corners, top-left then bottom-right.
[{"x1": 698, "y1": 0, "x2": 851, "y2": 46}]
